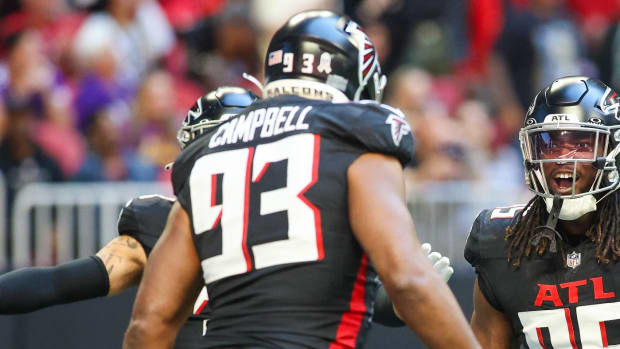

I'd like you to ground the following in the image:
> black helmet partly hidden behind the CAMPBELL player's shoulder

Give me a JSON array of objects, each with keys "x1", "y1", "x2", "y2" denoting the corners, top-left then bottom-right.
[{"x1": 177, "y1": 86, "x2": 258, "y2": 149}]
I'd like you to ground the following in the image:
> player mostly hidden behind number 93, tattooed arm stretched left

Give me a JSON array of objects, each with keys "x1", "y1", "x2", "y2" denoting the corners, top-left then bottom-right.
[{"x1": 0, "y1": 86, "x2": 257, "y2": 349}]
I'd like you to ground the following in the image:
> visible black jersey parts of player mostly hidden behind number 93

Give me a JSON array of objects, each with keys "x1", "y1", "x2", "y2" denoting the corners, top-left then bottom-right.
[{"x1": 118, "y1": 195, "x2": 209, "y2": 349}]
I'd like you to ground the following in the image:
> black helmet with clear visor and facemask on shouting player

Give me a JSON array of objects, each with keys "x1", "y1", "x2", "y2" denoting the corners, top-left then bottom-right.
[{"x1": 519, "y1": 76, "x2": 620, "y2": 199}]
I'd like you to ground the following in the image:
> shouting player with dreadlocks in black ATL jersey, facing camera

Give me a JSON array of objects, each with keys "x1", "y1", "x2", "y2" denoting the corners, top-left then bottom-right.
[{"x1": 465, "y1": 76, "x2": 620, "y2": 349}]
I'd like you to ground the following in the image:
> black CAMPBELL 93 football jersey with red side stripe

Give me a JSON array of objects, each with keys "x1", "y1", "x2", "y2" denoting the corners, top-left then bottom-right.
[{"x1": 172, "y1": 96, "x2": 413, "y2": 348}]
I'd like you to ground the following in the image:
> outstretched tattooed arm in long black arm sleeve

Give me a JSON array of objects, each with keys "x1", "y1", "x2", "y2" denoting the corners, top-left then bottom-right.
[{"x1": 0, "y1": 236, "x2": 146, "y2": 314}]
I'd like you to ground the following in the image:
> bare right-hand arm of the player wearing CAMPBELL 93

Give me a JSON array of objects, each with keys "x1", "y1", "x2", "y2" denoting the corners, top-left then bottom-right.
[{"x1": 348, "y1": 153, "x2": 479, "y2": 348}]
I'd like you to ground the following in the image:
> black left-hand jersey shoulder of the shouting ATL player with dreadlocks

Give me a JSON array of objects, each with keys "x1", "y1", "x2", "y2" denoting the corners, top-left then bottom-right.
[{"x1": 465, "y1": 205, "x2": 524, "y2": 267}]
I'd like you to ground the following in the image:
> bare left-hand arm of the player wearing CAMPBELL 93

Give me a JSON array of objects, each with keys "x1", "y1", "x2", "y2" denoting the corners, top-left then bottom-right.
[{"x1": 123, "y1": 202, "x2": 202, "y2": 349}]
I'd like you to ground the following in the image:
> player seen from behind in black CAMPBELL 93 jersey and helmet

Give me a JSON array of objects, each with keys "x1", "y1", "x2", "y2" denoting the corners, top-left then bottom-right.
[{"x1": 124, "y1": 11, "x2": 479, "y2": 349}]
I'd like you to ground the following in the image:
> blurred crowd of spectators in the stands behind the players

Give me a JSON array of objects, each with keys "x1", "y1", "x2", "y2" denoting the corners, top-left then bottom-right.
[{"x1": 0, "y1": 0, "x2": 620, "y2": 201}]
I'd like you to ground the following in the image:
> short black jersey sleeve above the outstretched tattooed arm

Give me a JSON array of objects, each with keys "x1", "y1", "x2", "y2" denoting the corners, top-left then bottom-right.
[{"x1": 118, "y1": 195, "x2": 174, "y2": 255}]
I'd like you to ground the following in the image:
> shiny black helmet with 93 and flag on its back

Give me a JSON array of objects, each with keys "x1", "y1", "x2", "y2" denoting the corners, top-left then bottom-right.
[{"x1": 265, "y1": 11, "x2": 387, "y2": 101}]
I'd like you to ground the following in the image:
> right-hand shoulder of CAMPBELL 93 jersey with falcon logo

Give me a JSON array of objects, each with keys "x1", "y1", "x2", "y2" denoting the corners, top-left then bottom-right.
[{"x1": 321, "y1": 101, "x2": 415, "y2": 166}]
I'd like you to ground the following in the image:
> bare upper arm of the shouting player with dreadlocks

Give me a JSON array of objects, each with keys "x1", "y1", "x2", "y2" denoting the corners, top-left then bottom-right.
[{"x1": 471, "y1": 278, "x2": 513, "y2": 349}]
